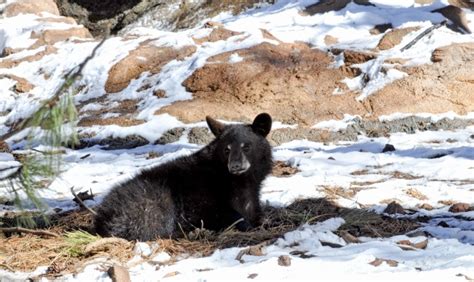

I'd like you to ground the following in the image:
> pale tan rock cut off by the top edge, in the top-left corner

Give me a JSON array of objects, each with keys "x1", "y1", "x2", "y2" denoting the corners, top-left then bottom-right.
[{"x1": 3, "y1": 0, "x2": 59, "y2": 17}]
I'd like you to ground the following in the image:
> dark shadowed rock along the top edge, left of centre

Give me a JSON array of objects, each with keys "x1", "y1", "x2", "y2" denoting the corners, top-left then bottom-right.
[{"x1": 56, "y1": 0, "x2": 272, "y2": 36}]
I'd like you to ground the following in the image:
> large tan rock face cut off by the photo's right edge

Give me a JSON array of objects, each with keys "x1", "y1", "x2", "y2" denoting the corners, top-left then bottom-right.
[{"x1": 368, "y1": 43, "x2": 474, "y2": 115}]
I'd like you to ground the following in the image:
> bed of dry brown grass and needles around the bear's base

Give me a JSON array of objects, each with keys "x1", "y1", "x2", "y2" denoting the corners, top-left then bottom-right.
[{"x1": 0, "y1": 198, "x2": 418, "y2": 277}]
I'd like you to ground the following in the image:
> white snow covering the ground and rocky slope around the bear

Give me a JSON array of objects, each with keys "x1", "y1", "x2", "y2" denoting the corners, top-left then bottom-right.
[{"x1": 0, "y1": 0, "x2": 474, "y2": 281}]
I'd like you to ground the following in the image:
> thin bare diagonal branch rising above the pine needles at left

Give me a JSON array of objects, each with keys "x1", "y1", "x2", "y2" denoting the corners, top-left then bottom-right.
[{"x1": 0, "y1": 36, "x2": 108, "y2": 140}]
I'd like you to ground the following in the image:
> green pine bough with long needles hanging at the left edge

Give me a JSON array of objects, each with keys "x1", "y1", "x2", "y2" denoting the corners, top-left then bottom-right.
[{"x1": 0, "y1": 36, "x2": 108, "y2": 227}]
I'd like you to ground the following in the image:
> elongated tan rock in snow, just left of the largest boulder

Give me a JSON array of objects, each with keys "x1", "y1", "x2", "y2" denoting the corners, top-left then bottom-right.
[{"x1": 105, "y1": 42, "x2": 196, "y2": 93}]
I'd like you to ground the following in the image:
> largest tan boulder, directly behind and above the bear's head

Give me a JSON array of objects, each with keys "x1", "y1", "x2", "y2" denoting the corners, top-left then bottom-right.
[{"x1": 157, "y1": 43, "x2": 365, "y2": 125}]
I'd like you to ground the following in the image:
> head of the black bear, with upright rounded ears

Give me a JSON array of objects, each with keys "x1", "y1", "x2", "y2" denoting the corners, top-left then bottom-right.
[{"x1": 206, "y1": 113, "x2": 272, "y2": 175}]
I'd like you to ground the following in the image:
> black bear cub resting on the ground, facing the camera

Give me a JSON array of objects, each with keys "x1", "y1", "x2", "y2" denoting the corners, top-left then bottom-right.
[{"x1": 94, "y1": 113, "x2": 272, "y2": 241}]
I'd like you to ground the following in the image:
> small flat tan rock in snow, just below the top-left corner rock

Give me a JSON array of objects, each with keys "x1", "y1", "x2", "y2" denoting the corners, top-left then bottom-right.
[{"x1": 29, "y1": 27, "x2": 92, "y2": 49}]
